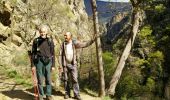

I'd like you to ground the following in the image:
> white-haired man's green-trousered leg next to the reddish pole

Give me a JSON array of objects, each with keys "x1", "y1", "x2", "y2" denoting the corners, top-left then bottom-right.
[{"x1": 36, "y1": 61, "x2": 44, "y2": 96}]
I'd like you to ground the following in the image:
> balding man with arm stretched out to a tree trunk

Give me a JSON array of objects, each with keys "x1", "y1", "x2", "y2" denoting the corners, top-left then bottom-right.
[{"x1": 59, "y1": 32, "x2": 95, "y2": 100}]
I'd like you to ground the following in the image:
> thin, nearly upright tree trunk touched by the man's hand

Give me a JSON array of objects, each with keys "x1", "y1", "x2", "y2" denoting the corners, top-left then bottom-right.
[{"x1": 91, "y1": 0, "x2": 105, "y2": 97}]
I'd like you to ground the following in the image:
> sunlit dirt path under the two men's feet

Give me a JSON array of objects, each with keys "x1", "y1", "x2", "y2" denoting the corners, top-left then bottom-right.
[{"x1": 0, "y1": 69, "x2": 101, "y2": 100}]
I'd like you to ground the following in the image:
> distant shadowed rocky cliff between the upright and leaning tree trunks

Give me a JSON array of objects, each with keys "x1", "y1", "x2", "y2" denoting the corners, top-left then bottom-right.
[{"x1": 102, "y1": 12, "x2": 130, "y2": 51}]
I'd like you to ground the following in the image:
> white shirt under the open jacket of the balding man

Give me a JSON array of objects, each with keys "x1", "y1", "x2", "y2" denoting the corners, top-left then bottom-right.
[{"x1": 66, "y1": 42, "x2": 73, "y2": 63}]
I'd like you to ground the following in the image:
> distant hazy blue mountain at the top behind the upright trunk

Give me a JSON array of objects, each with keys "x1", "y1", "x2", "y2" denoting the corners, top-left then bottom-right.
[{"x1": 84, "y1": 0, "x2": 131, "y2": 23}]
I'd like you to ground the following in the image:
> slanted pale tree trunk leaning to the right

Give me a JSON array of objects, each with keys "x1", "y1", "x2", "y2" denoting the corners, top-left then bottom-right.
[{"x1": 107, "y1": 9, "x2": 140, "y2": 96}]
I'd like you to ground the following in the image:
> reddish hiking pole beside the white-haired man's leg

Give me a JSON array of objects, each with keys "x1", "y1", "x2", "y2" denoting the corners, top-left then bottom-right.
[{"x1": 32, "y1": 71, "x2": 39, "y2": 100}]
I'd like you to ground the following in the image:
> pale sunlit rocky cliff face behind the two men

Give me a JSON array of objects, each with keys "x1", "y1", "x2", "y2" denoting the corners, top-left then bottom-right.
[{"x1": 0, "y1": 0, "x2": 90, "y2": 72}]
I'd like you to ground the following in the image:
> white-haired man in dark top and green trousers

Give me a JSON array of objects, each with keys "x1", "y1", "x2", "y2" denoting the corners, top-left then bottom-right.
[{"x1": 31, "y1": 25, "x2": 55, "y2": 100}]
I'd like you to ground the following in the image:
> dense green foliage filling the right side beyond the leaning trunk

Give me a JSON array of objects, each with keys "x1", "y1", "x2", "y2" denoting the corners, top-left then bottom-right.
[{"x1": 113, "y1": 0, "x2": 170, "y2": 100}]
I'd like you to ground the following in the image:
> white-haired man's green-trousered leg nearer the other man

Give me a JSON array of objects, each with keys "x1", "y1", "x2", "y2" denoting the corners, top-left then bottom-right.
[{"x1": 45, "y1": 62, "x2": 52, "y2": 96}]
